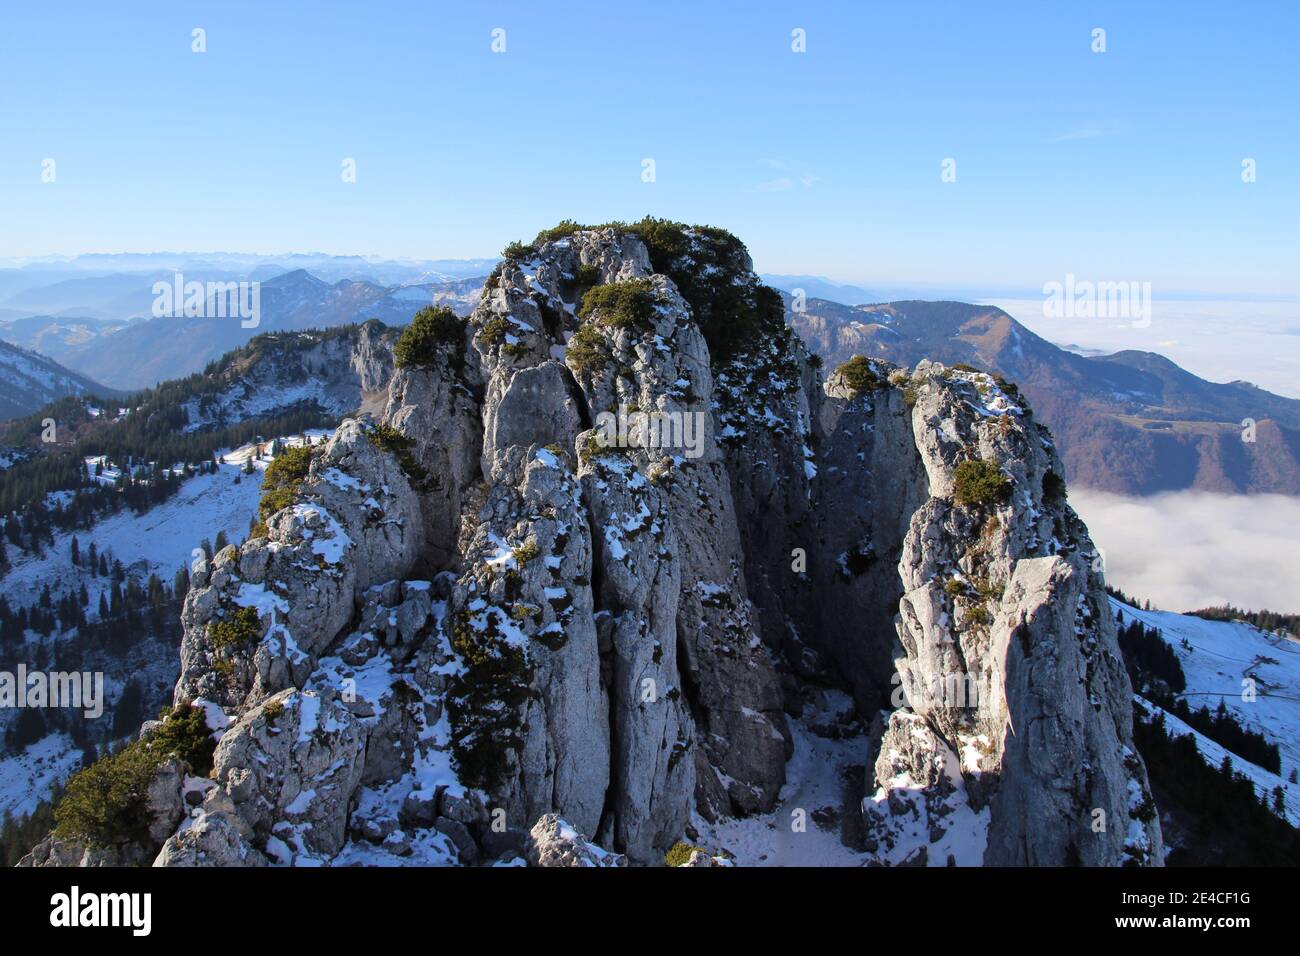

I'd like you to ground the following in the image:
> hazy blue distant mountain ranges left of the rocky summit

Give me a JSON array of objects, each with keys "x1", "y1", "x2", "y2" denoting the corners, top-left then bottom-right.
[{"x1": 0, "y1": 252, "x2": 497, "y2": 400}]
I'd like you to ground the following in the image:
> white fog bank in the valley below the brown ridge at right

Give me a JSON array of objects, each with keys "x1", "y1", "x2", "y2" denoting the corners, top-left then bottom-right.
[{"x1": 1070, "y1": 488, "x2": 1300, "y2": 613}]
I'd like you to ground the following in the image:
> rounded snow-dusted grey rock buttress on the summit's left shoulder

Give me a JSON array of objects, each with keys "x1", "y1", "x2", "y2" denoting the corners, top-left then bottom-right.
[{"x1": 176, "y1": 419, "x2": 424, "y2": 708}]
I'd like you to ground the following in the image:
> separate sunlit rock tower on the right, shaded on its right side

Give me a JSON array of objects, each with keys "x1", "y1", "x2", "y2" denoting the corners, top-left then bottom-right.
[{"x1": 868, "y1": 362, "x2": 1162, "y2": 865}]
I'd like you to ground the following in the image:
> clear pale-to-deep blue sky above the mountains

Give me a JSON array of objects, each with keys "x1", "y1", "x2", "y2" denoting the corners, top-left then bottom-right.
[{"x1": 0, "y1": 0, "x2": 1300, "y2": 293}]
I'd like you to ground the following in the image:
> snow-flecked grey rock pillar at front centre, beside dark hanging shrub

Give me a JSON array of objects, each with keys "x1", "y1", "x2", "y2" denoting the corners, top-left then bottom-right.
[{"x1": 450, "y1": 446, "x2": 610, "y2": 832}]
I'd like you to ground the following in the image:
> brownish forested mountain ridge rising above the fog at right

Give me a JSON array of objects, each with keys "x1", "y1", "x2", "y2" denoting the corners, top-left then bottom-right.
[{"x1": 784, "y1": 294, "x2": 1300, "y2": 494}]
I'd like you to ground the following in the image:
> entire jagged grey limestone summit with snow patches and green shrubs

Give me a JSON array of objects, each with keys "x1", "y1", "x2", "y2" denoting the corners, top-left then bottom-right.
[{"x1": 26, "y1": 220, "x2": 1164, "y2": 866}]
